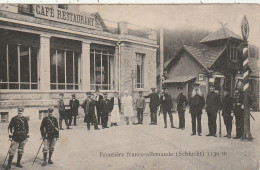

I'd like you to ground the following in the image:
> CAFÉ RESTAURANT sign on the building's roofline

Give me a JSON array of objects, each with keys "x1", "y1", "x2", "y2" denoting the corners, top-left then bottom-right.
[{"x1": 34, "y1": 5, "x2": 100, "y2": 29}]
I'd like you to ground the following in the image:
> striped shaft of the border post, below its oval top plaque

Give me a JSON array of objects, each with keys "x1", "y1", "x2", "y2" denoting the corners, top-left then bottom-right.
[{"x1": 242, "y1": 43, "x2": 253, "y2": 140}]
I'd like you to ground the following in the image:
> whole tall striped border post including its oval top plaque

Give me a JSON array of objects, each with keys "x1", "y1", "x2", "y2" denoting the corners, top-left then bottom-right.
[{"x1": 241, "y1": 16, "x2": 253, "y2": 141}]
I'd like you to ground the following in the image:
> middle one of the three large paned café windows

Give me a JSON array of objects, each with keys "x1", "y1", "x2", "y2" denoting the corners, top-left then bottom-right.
[{"x1": 50, "y1": 49, "x2": 80, "y2": 90}]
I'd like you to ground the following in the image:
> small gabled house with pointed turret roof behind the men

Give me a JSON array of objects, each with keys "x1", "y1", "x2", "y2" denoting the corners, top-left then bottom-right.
[{"x1": 161, "y1": 28, "x2": 251, "y2": 109}]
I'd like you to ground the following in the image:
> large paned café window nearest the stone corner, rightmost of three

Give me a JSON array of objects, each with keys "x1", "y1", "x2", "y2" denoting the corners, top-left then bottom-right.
[{"x1": 90, "y1": 50, "x2": 114, "y2": 90}]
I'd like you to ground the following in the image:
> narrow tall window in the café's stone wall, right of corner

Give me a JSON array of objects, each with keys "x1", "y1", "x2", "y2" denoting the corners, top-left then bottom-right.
[{"x1": 135, "y1": 53, "x2": 145, "y2": 88}]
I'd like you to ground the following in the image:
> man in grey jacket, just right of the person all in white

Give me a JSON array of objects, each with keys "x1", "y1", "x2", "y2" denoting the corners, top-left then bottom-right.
[{"x1": 135, "y1": 91, "x2": 146, "y2": 124}]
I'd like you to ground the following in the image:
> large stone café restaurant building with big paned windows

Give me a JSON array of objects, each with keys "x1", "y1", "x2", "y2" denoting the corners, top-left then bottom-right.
[{"x1": 0, "y1": 4, "x2": 158, "y2": 122}]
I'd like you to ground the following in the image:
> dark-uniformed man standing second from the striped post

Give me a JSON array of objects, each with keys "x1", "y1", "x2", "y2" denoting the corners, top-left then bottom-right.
[{"x1": 221, "y1": 88, "x2": 233, "y2": 138}]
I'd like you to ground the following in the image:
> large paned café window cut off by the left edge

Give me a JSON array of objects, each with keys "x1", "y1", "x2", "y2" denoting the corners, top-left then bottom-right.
[{"x1": 0, "y1": 44, "x2": 38, "y2": 89}]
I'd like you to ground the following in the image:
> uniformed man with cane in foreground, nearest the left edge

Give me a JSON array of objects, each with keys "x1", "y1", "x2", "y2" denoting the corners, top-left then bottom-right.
[{"x1": 5, "y1": 108, "x2": 29, "y2": 169}]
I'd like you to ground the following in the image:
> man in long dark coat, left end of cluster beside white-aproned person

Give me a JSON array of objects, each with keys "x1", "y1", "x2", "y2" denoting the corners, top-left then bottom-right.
[{"x1": 82, "y1": 92, "x2": 99, "y2": 130}]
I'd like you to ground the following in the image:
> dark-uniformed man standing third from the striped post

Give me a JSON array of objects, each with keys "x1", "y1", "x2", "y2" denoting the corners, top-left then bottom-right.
[{"x1": 206, "y1": 85, "x2": 220, "y2": 137}]
